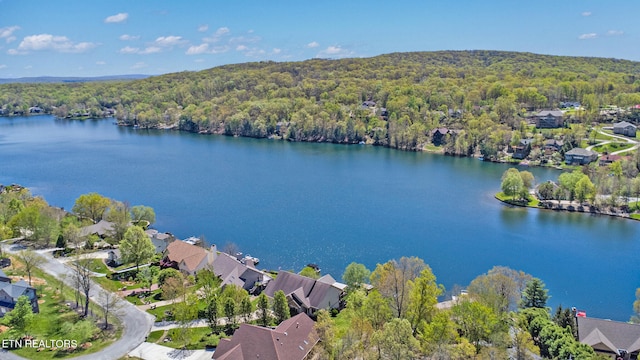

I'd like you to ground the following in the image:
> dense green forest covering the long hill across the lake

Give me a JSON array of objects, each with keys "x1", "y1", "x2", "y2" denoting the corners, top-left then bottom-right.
[{"x1": 0, "y1": 51, "x2": 640, "y2": 155}]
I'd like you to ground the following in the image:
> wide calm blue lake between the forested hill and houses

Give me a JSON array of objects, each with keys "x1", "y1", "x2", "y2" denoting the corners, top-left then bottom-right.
[{"x1": 0, "y1": 116, "x2": 640, "y2": 321}]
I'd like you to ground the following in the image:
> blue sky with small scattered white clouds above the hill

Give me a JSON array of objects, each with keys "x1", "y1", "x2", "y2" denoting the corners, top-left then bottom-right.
[{"x1": 0, "y1": 0, "x2": 640, "y2": 78}]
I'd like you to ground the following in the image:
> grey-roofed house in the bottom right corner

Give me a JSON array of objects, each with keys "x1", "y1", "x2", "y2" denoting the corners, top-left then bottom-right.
[{"x1": 576, "y1": 316, "x2": 640, "y2": 359}]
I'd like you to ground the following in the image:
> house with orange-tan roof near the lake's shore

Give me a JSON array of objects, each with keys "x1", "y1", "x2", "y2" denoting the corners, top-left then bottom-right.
[{"x1": 160, "y1": 240, "x2": 215, "y2": 275}]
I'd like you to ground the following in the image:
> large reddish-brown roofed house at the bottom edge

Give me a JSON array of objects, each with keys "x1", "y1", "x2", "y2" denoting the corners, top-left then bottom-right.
[{"x1": 212, "y1": 314, "x2": 320, "y2": 360}]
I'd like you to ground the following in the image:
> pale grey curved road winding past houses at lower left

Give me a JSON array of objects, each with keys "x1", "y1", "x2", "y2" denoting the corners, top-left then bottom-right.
[{"x1": 0, "y1": 247, "x2": 155, "y2": 360}]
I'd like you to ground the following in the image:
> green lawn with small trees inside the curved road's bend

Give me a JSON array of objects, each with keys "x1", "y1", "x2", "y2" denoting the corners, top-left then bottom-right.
[{"x1": 0, "y1": 258, "x2": 122, "y2": 359}]
